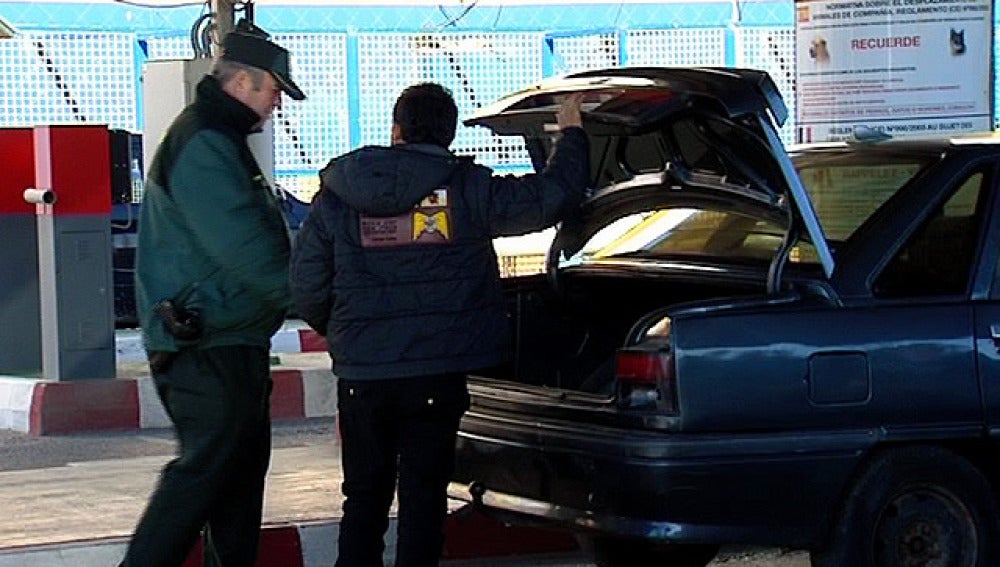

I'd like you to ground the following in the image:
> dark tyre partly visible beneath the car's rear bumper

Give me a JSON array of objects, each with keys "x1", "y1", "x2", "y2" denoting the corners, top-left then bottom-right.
[{"x1": 577, "y1": 535, "x2": 719, "y2": 567}]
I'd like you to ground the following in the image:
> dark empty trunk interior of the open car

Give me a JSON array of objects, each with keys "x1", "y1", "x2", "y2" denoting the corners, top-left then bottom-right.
[{"x1": 478, "y1": 270, "x2": 764, "y2": 396}]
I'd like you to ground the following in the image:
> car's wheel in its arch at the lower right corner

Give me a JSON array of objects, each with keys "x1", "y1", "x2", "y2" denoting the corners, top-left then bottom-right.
[{"x1": 810, "y1": 447, "x2": 1000, "y2": 567}]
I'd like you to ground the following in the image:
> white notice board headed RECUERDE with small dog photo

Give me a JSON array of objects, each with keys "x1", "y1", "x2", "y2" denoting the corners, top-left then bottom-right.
[{"x1": 795, "y1": 0, "x2": 993, "y2": 142}]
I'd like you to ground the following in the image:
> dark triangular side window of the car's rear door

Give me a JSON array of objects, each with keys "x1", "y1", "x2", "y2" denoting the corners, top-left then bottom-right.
[{"x1": 873, "y1": 172, "x2": 985, "y2": 298}]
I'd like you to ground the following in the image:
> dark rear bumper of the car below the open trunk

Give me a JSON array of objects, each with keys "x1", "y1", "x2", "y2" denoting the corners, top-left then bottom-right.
[{"x1": 449, "y1": 413, "x2": 873, "y2": 546}]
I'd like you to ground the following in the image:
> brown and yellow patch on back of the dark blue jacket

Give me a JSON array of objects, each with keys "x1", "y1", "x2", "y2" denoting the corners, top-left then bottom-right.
[{"x1": 359, "y1": 186, "x2": 454, "y2": 248}]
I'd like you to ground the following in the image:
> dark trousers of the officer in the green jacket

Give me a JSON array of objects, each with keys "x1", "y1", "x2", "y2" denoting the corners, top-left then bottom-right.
[{"x1": 122, "y1": 346, "x2": 271, "y2": 567}]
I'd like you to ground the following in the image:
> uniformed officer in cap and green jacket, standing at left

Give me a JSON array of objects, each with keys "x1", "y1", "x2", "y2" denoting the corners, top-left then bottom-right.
[{"x1": 123, "y1": 22, "x2": 305, "y2": 567}]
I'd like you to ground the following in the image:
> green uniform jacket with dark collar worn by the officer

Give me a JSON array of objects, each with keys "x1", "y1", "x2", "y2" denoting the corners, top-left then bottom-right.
[{"x1": 136, "y1": 76, "x2": 290, "y2": 351}]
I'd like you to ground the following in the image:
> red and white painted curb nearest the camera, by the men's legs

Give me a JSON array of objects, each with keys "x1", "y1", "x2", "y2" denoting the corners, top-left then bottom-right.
[{"x1": 0, "y1": 509, "x2": 577, "y2": 567}]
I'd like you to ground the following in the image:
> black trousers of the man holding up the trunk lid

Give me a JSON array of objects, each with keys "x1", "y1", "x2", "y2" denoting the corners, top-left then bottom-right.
[{"x1": 336, "y1": 374, "x2": 469, "y2": 567}]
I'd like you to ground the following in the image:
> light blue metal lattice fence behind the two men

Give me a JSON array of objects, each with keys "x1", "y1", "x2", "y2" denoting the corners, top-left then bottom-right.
[{"x1": 0, "y1": 0, "x2": 1000, "y2": 201}]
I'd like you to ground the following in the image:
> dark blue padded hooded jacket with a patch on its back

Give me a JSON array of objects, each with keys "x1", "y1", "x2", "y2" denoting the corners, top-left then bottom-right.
[{"x1": 291, "y1": 128, "x2": 590, "y2": 380}]
